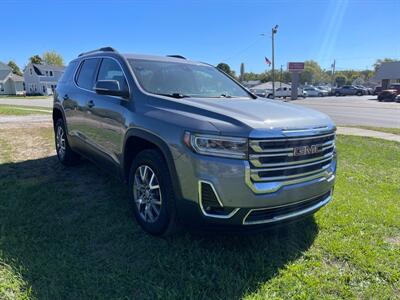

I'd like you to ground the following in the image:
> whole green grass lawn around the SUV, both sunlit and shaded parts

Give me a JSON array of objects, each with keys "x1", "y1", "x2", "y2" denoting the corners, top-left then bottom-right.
[{"x1": 0, "y1": 129, "x2": 400, "y2": 299}]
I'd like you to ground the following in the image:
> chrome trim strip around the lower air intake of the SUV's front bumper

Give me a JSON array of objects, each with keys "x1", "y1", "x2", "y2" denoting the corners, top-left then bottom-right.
[{"x1": 242, "y1": 190, "x2": 332, "y2": 225}]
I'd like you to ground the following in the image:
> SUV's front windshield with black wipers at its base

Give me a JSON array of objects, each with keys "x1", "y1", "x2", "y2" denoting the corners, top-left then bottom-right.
[{"x1": 129, "y1": 59, "x2": 250, "y2": 98}]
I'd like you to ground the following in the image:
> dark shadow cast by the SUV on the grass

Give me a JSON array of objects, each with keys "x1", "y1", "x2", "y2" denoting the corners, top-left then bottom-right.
[{"x1": 0, "y1": 156, "x2": 318, "y2": 299}]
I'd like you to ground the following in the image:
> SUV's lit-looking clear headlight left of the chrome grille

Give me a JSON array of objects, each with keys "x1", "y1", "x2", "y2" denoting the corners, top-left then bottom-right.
[{"x1": 183, "y1": 132, "x2": 248, "y2": 159}]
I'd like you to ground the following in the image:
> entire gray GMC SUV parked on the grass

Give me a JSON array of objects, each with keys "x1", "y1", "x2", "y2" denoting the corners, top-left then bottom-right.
[{"x1": 53, "y1": 47, "x2": 336, "y2": 235}]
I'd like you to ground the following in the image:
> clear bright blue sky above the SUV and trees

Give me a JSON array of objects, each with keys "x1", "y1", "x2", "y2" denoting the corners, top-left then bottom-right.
[{"x1": 0, "y1": 0, "x2": 400, "y2": 72}]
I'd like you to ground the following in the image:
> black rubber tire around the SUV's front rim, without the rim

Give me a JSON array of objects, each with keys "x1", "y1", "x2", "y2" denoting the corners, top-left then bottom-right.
[{"x1": 129, "y1": 150, "x2": 175, "y2": 235}]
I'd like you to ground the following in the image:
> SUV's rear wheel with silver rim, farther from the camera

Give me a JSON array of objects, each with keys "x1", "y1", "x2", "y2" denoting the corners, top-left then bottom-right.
[{"x1": 54, "y1": 119, "x2": 80, "y2": 166}]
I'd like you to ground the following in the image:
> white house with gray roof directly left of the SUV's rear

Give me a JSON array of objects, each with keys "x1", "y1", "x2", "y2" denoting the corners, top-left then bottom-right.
[{"x1": 24, "y1": 63, "x2": 65, "y2": 95}]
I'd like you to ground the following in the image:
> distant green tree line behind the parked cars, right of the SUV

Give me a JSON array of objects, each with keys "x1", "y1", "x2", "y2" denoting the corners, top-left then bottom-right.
[{"x1": 217, "y1": 58, "x2": 397, "y2": 86}]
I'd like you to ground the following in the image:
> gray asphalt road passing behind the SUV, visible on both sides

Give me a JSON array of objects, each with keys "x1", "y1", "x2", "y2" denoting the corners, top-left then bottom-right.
[{"x1": 0, "y1": 96, "x2": 400, "y2": 128}]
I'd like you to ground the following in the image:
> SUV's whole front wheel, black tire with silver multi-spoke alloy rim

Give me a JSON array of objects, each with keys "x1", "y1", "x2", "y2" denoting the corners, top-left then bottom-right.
[{"x1": 129, "y1": 149, "x2": 177, "y2": 236}]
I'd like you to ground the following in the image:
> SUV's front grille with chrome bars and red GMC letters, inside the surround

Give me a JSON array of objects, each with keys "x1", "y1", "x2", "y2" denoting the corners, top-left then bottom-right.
[{"x1": 249, "y1": 132, "x2": 335, "y2": 182}]
